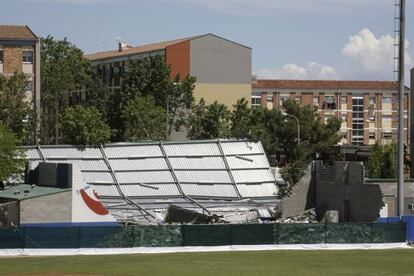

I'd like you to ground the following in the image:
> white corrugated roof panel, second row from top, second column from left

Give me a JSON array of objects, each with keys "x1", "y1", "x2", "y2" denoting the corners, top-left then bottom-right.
[{"x1": 109, "y1": 158, "x2": 168, "y2": 171}]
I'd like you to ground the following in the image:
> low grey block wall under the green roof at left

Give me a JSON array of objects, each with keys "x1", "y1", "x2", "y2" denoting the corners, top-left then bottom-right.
[{"x1": 20, "y1": 191, "x2": 72, "y2": 224}]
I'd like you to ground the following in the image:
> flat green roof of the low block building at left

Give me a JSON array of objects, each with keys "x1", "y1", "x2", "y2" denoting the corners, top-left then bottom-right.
[{"x1": 0, "y1": 184, "x2": 70, "y2": 200}]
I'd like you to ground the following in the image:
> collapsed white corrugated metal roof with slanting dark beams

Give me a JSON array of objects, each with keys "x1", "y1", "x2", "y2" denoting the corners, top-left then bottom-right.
[{"x1": 25, "y1": 140, "x2": 278, "y2": 224}]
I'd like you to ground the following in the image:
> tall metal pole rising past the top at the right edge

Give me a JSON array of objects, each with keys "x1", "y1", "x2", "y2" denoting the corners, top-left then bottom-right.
[{"x1": 397, "y1": 0, "x2": 405, "y2": 216}]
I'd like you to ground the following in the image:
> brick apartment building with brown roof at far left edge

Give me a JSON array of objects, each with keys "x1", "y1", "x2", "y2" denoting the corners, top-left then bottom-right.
[{"x1": 0, "y1": 25, "x2": 40, "y2": 124}]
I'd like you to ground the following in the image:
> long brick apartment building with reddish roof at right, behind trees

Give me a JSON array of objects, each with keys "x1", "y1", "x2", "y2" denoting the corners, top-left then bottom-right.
[{"x1": 251, "y1": 79, "x2": 410, "y2": 146}]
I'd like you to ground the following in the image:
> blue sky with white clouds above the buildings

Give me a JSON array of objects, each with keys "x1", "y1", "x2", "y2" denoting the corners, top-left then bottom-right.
[{"x1": 0, "y1": 0, "x2": 414, "y2": 83}]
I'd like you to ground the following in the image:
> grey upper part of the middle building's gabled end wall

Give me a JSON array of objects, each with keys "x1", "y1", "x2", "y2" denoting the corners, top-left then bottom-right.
[{"x1": 190, "y1": 34, "x2": 252, "y2": 83}]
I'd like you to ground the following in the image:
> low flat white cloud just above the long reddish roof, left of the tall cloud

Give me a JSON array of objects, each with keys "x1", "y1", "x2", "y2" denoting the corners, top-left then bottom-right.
[{"x1": 254, "y1": 62, "x2": 338, "y2": 80}]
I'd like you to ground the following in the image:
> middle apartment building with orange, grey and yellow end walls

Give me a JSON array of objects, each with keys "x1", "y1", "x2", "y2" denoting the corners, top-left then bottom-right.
[{"x1": 85, "y1": 34, "x2": 251, "y2": 108}]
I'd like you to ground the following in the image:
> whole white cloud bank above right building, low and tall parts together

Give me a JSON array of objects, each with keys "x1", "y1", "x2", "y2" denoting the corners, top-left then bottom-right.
[{"x1": 254, "y1": 28, "x2": 413, "y2": 82}]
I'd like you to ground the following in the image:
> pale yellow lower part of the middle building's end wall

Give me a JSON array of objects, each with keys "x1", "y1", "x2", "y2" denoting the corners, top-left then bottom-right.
[{"x1": 194, "y1": 83, "x2": 251, "y2": 108}]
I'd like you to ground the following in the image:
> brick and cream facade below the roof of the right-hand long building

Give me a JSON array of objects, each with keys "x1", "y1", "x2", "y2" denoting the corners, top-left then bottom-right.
[{"x1": 251, "y1": 88, "x2": 412, "y2": 145}]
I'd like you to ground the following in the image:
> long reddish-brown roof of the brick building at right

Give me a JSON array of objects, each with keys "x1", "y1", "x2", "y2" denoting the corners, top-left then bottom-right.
[{"x1": 252, "y1": 79, "x2": 404, "y2": 90}]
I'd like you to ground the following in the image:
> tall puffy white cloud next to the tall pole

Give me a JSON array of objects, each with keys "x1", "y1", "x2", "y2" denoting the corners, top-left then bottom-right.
[{"x1": 341, "y1": 29, "x2": 412, "y2": 79}]
